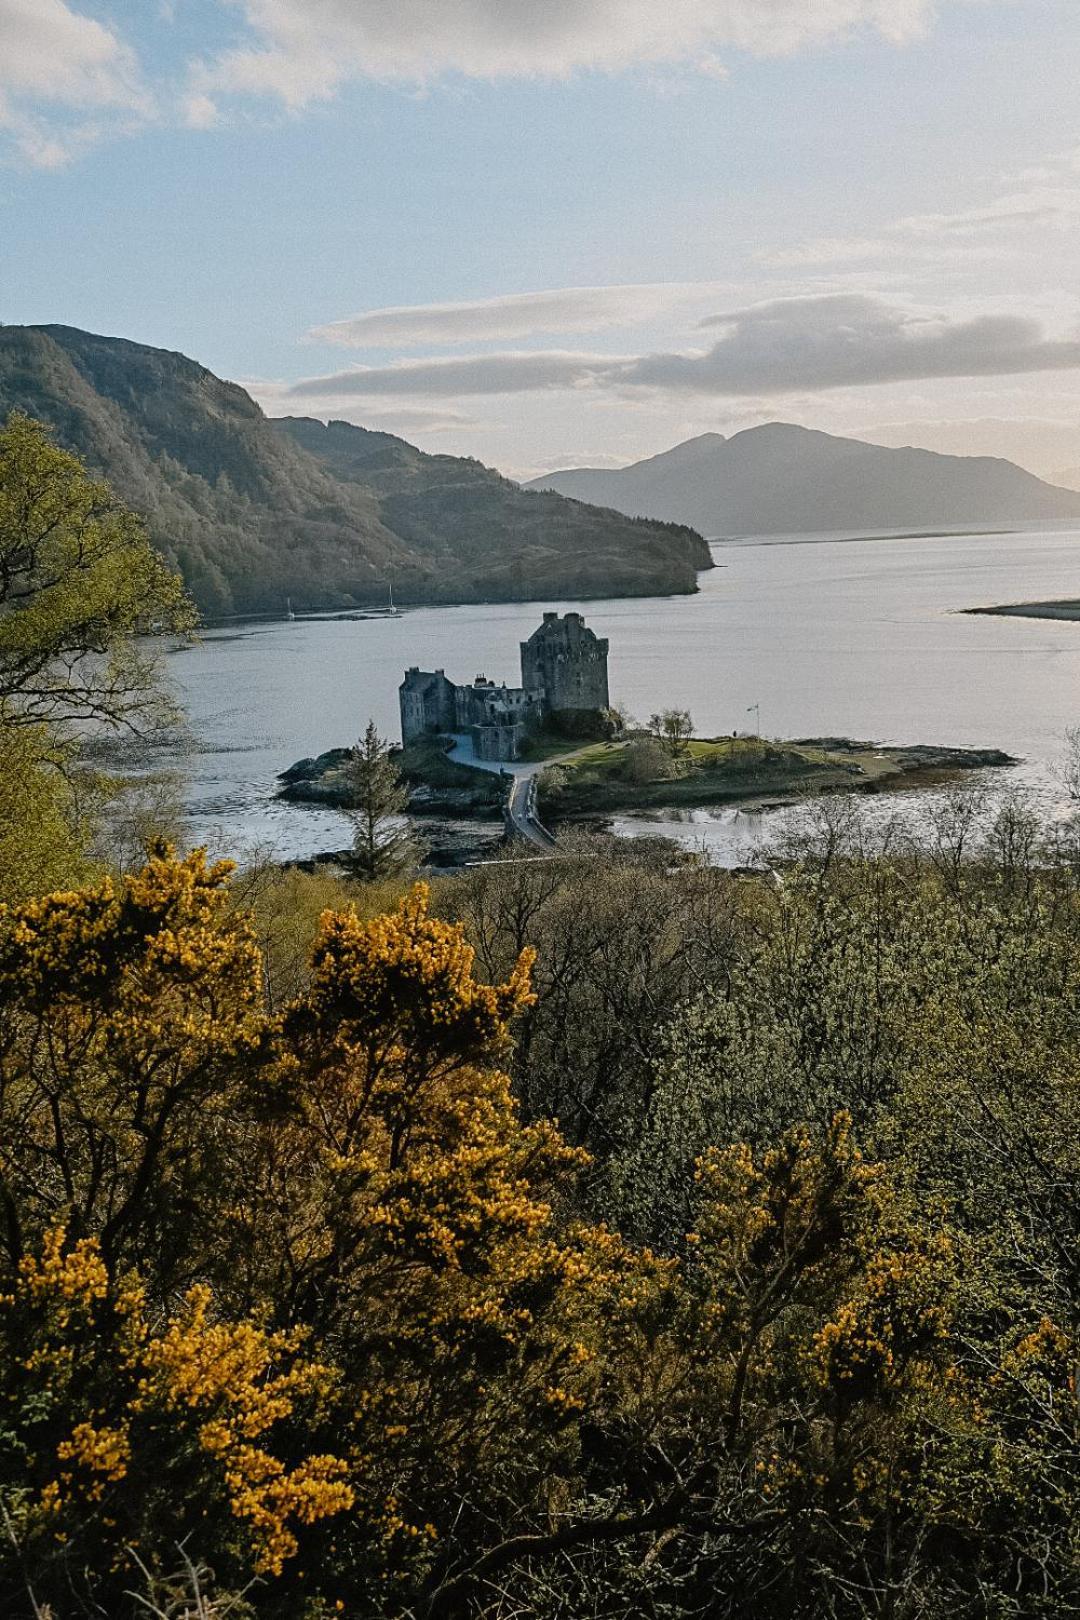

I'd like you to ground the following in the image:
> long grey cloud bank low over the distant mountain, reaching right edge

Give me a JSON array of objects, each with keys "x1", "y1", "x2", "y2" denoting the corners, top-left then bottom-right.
[{"x1": 281, "y1": 293, "x2": 1080, "y2": 399}]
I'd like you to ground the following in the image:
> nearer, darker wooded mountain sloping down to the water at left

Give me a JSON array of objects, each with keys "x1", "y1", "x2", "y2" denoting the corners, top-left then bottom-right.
[{"x1": 0, "y1": 326, "x2": 711, "y2": 614}]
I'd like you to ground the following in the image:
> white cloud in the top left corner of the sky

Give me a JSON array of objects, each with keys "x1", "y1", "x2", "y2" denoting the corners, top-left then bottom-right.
[{"x1": 0, "y1": 0, "x2": 151, "y2": 168}]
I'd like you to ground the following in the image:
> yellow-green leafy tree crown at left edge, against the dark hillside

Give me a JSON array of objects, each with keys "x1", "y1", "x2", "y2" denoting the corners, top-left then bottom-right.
[{"x1": 0, "y1": 411, "x2": 194, "y2": 727}]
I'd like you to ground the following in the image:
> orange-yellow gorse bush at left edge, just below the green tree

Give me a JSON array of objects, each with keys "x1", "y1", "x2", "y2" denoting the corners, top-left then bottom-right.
[{"x1": 0, "y1": 852, "x2": 264, "y2": 1283}]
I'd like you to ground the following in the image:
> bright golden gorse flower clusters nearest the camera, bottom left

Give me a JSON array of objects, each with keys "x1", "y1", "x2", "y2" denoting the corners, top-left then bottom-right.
[{"x1": 0, "y1": 1228, "x2": 353, "y2": 1575}]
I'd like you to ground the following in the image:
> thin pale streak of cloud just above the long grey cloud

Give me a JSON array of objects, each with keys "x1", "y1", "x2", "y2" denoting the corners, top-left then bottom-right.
[{"x1": 308, "y1": 282, "x2": 717, "y2": 348}]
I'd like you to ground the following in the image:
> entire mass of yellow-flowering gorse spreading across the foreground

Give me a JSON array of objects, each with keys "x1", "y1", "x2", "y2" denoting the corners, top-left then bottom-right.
[{"x1": 0, "y1": 852, "x2": 1003, "y2": 1617}]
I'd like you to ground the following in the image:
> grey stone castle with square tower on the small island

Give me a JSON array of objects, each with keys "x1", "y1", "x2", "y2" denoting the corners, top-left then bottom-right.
[{"x1": 398, "y1": 612, "x2": 609, "y2": 760}]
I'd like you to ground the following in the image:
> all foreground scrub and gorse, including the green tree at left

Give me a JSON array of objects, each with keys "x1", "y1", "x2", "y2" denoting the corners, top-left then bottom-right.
[{"x1": 0, "y1": 423, "x2": 1080, "y2": 1620}]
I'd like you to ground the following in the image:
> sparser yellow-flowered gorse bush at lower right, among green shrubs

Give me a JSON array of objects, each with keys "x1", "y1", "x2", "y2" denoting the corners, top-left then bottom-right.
[{"x1": 688, "y1": 1113, "x2": 960, "y2": 1531}]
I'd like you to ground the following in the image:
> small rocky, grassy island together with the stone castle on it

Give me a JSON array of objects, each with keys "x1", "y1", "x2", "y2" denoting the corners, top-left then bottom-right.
[{"x1": 280, "y1": 612, "x2": 1017, "y2": 865}]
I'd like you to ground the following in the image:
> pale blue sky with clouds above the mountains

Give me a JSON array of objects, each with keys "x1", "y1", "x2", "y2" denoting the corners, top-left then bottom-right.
[{"x1": 0, "y1": 0, "x2": 1080, "y2": 486}]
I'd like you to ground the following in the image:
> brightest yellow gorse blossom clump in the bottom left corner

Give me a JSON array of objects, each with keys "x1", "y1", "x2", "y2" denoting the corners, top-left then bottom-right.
[{"x1": 0, "y1": 1228, "x2": 353, "y2": 1575}]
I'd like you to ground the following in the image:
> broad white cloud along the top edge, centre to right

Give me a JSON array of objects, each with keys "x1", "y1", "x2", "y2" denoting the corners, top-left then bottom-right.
[{"x1": 191, "y1": 0, "x2": 934, "y2": 110}]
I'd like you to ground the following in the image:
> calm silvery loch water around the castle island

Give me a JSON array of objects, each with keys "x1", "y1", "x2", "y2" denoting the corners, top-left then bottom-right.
[{"x1": 167, "y1": 528, "x2": 1080, "y2": 859}]
